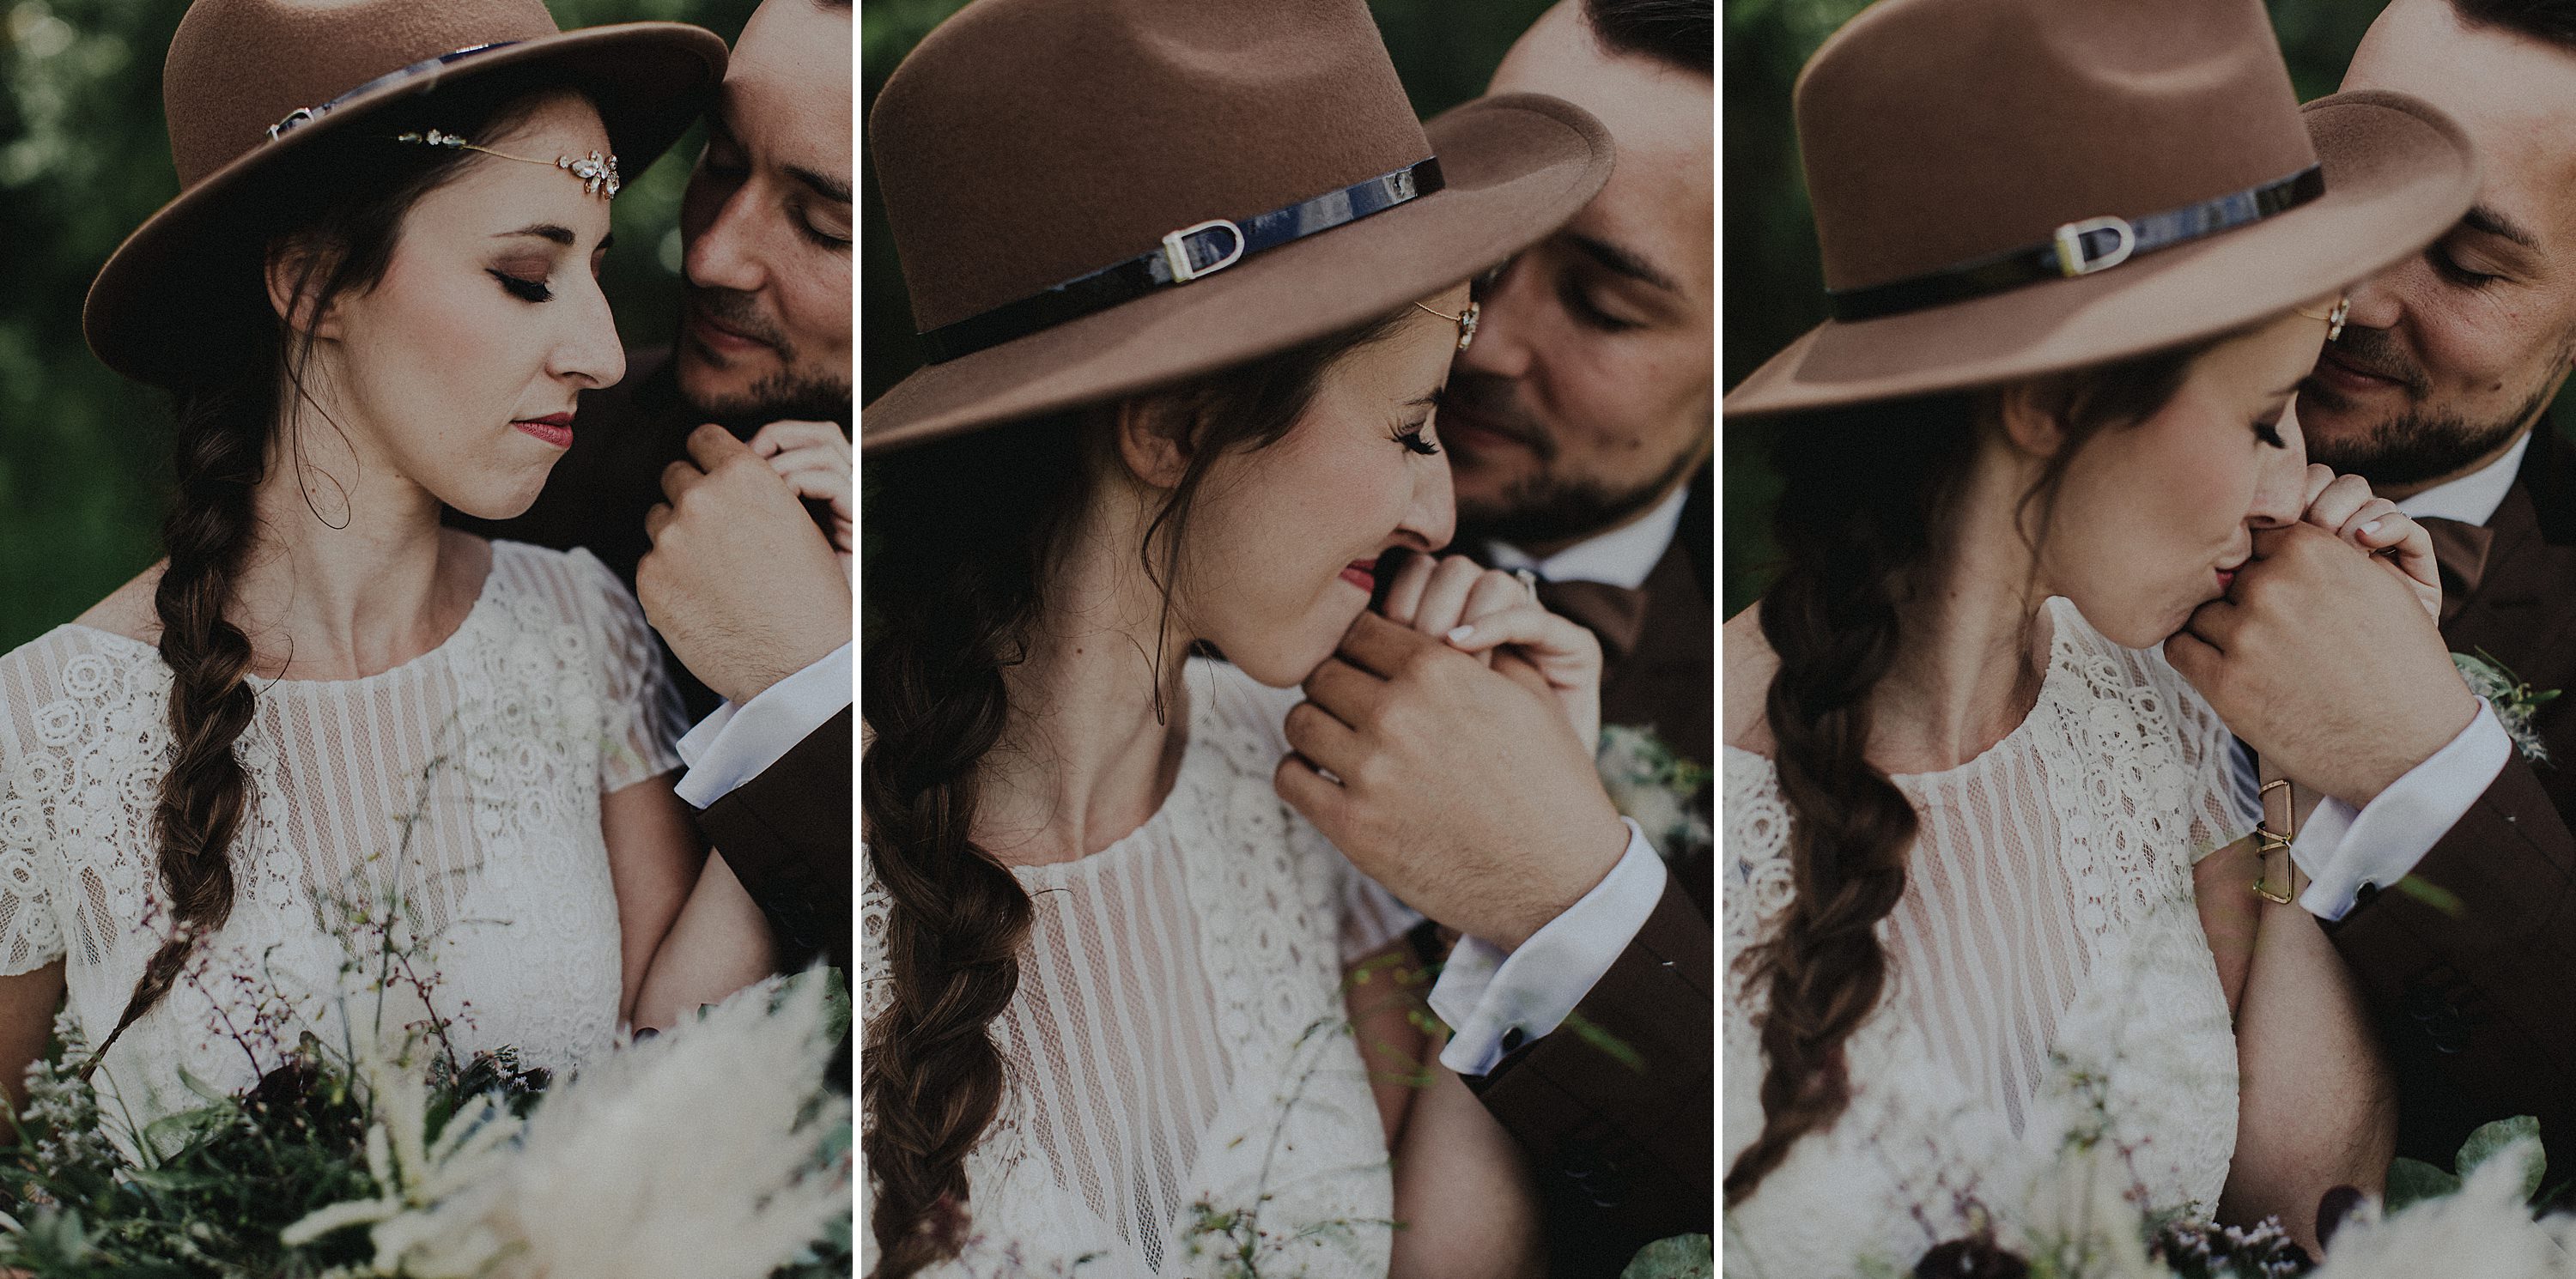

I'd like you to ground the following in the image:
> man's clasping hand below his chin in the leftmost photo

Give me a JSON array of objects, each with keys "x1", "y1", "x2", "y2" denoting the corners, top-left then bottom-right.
[{"x1": 636, "y1": 425, "x2": 850, "y2": 705}]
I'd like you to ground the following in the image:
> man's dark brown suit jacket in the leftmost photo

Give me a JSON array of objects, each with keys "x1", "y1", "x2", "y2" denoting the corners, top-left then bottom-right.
[{"x1": 448, "y1": 350, "x2": 855, "y2": 973}]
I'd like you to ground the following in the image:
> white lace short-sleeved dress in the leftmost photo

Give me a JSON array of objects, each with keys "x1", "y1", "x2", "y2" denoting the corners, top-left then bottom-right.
[{"x1": 0, "y1": 543, "x2": 680, "y2": 1137}]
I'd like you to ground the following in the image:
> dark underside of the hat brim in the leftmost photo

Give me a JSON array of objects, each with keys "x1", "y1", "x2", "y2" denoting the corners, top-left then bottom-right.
[{"x1": 80, "y1": 23, "x2": 726, "y2": 386}]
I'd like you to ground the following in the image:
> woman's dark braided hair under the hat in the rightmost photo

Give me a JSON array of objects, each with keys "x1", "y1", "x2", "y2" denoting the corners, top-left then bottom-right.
[{"x1": 1726, "y1": 337, "x2": 2221, "y2": 1204}]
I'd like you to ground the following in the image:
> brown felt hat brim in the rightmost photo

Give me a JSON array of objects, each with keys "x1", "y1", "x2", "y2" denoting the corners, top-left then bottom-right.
[{"x1": 1723, "y1": 93, "x2": 2478, "y2": 417}]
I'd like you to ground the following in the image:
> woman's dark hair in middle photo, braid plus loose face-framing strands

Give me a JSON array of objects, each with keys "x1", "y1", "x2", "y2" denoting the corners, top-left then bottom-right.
[{"x1": 858, "y1": 312, "x2": 1412, "y2": 1279}]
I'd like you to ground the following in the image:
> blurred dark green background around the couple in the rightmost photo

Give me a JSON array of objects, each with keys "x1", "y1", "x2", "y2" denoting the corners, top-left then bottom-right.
[{"x1": 1718, "y1": 0, "x2": 2571, "y2": 615}]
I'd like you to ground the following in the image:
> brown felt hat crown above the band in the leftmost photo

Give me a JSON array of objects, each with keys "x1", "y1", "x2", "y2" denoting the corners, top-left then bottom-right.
[{"x1": 162, "y1": 0, "x2": 559, "y2": 191}]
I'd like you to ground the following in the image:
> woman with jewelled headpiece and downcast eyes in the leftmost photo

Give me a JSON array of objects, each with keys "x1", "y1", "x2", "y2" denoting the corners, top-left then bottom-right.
[{"x1": 0, "y1": 0, "x2": 770, "y2": 1132}]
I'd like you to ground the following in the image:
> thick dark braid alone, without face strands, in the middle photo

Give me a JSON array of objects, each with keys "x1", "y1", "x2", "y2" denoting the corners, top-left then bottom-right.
[{"x1": 860, "y1": 422, "x2": 1079, "y2": 1279}]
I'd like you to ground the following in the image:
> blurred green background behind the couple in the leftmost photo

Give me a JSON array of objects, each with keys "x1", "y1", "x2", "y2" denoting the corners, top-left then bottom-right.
[{"x1": 0, "y1": 0, "x2": 757, "y2": 651}]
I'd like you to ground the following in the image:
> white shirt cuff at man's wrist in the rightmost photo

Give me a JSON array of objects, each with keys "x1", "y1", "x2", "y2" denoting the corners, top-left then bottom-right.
[{"x1": 2290, "y1": 697, "x2": 2514, "y2": 918}]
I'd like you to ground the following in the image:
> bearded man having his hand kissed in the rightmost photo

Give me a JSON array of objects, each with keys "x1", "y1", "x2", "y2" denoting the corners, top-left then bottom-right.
[{"x1": 2169, "y1": 0, "x2": 2576, "y2": 1184}]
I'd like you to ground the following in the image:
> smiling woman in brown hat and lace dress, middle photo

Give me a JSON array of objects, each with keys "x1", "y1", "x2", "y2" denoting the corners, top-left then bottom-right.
[{"x1": 860, "y1": 0, "x2": 1610, "y2": 1279}]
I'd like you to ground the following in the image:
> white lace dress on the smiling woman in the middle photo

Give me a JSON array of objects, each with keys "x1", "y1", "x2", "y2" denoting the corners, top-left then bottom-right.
[{"x1": 860, "y1": 658, "x2": 1419, "y2": 1279}]
